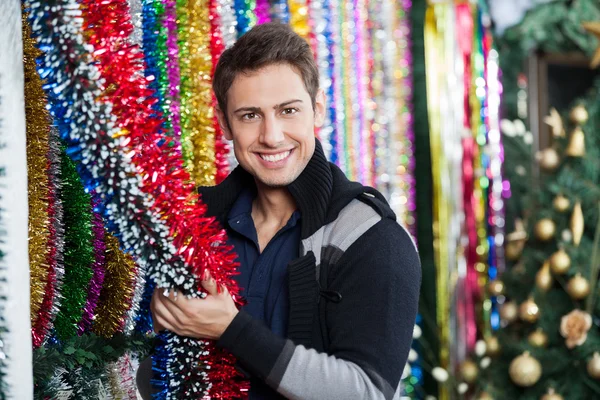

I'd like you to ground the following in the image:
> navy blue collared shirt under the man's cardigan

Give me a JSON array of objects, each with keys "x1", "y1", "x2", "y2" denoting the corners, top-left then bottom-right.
[{"x1": 227, "y1": 189, "x2": 301, "y2": 400}]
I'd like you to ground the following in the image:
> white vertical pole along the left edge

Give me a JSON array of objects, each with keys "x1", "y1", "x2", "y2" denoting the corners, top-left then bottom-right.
[{"x1": 0, "y1": 0, "x2": 33, "y2": 400}]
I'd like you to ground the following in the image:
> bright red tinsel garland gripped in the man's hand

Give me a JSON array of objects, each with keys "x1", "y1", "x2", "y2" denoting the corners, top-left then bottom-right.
[{"x1": 82, "y1": 0, "x2": 247, "y2": 399}]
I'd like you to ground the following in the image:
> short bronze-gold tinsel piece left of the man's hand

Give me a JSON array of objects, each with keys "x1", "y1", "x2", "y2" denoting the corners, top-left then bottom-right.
[{"x1": 93, "y1": 234, "x2": 136, "y2": 337}]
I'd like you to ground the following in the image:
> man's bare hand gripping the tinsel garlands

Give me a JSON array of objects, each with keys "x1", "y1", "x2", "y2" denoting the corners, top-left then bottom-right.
[{"x1": 150, "y1": 271, "x2": 238, "y2": 340}]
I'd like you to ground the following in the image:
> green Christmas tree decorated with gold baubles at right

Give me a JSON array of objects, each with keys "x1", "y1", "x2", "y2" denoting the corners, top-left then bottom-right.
[{"x1": 479, "y1": 89, "x2": 600, "y2": 400}]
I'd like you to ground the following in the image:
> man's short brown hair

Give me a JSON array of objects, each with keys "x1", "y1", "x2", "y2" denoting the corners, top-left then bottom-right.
[{"x1": 213, "y1": 22, "x2": 319, "y2": 116}]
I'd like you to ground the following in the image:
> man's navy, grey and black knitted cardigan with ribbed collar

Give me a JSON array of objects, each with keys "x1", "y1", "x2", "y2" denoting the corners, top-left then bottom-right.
[{"x1": 199, "y1": 141, "x2": 421, "y2": 400}]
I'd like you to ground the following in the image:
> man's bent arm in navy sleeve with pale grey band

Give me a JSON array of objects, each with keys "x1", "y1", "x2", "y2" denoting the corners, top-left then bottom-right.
[{"x1": 218, "y1": 219, "x2": 421, "y2": 400}]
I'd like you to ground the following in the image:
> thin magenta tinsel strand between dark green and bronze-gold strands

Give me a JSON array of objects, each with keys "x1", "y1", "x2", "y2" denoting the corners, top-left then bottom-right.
[{"x1": 77, "y1": 194, "x2": 106, "y2": 335}]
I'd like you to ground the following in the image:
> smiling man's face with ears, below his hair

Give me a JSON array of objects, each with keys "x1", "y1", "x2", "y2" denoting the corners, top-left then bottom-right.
[{"x1": 217, "y1": 64, "x2": 325, "y2": 187}]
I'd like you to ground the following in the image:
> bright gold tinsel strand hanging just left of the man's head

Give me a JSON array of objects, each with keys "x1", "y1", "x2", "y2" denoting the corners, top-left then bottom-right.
[{"x1": 179, "y1": 0, "x2": 216, "y2": 186}]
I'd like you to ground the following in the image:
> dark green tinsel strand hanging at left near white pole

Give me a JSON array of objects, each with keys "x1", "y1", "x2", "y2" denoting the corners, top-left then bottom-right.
[{"x1": 54, "y1": 151, "x2": 94, "y2": 340}]
